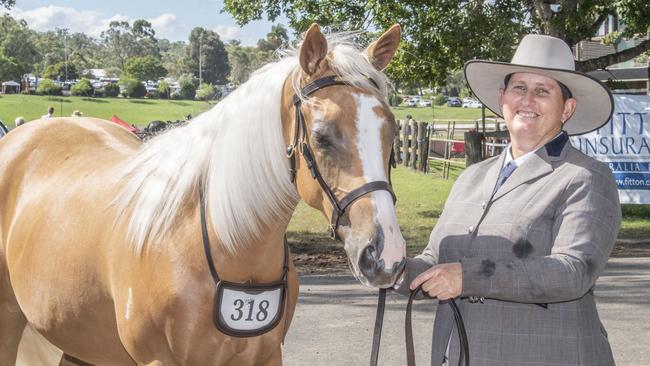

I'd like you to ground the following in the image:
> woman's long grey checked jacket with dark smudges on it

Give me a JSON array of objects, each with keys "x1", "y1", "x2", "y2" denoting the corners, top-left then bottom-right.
[{"x1": 398, "y1": 133, "x2": 621, "y2": 366}]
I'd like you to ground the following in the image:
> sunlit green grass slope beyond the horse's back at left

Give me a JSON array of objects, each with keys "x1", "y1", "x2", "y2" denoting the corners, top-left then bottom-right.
[{"x1": 0, "y1": 94, "x2": 212, "y2": 128}]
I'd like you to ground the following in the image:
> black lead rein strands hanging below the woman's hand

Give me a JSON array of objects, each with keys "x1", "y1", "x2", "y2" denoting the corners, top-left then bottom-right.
[{"x1": 370, "y1": 286, "x2": 469, "y2": 366}]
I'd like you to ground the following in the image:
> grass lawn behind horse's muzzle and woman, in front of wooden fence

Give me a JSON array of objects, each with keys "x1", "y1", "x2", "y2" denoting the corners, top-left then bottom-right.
[{"x1": 288, "y1": 164, "x2": 650, "y2": 255}]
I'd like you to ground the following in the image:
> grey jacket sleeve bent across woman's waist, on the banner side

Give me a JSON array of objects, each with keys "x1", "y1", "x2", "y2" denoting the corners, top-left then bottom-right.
[{"x1": 461, "y1": 163, "x2": 621, "y2": 303}]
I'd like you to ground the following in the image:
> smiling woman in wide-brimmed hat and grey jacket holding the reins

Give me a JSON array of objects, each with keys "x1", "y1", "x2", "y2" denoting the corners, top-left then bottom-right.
[{"x1": 396, "y1": 35, "x2": 621, "y2": 365}]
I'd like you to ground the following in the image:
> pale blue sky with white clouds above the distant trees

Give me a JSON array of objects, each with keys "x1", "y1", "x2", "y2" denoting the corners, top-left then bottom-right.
[{"x1": 2, "y1": 0, "x2": 291, "y2": 46}]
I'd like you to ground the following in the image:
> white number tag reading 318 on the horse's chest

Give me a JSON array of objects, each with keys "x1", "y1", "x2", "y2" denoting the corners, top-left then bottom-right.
[{"x1": 217, "y1": 287, "x2": 284, "y2": 333}]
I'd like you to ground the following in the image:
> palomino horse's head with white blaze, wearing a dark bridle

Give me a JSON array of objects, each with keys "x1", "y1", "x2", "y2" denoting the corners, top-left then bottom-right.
[{"x1": 282, "y1": 24, "x2": 405, "y2": 287}]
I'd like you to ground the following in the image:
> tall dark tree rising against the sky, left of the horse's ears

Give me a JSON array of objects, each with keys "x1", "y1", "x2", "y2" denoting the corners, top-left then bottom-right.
[{"x1": 185, "y1": 27, "x2": 230, "y2": 84}]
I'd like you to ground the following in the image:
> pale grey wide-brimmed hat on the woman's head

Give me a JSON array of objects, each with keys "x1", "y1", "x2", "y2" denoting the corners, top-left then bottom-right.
[{"x1": 465, "y1": 34, "x2": 614, "y2": 135}]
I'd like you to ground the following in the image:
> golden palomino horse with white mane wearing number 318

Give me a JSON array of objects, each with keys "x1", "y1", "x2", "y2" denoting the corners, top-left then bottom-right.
[{"x1": 0, "y1": 25, "x2": 405, "y2": 366}]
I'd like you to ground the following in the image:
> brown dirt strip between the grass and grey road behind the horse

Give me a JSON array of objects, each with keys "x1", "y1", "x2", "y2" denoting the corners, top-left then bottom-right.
[{"x1": 289, "y1": 238, "x2": 650, "y2": 274}]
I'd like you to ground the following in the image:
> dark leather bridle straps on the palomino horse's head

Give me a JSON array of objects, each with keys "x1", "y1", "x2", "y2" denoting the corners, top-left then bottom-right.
[{"x1": 287, "y1": 76, "x2": 397, "y2": 239}]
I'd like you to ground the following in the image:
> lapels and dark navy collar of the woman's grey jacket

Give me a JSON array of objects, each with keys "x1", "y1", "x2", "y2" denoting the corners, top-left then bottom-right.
[{"x1": 484, "y1": 131, "x2": 571, "y2": 201}]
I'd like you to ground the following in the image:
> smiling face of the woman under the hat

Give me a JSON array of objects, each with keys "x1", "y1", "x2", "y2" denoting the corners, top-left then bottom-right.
[{"x1": 499, "y1": 73, "x2": 576, "y2": 155}]
